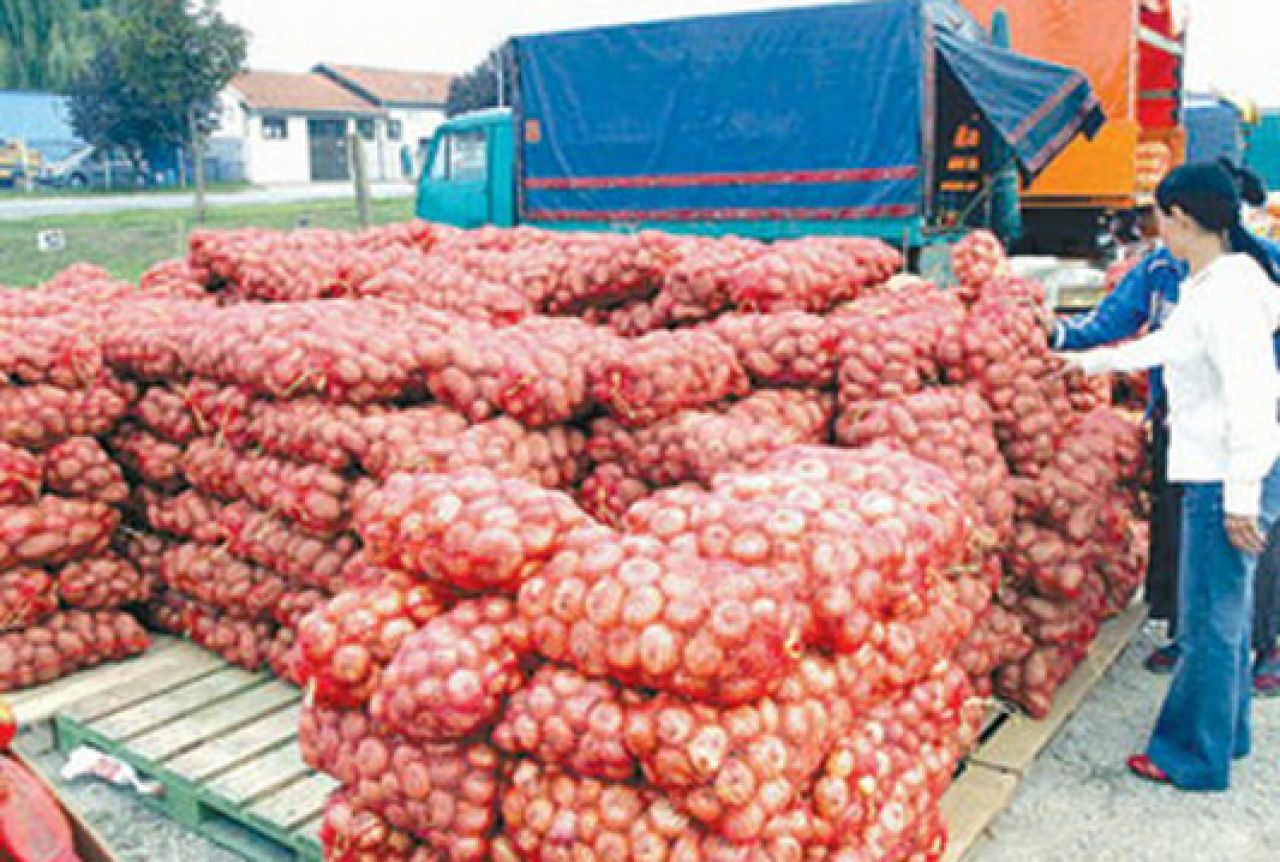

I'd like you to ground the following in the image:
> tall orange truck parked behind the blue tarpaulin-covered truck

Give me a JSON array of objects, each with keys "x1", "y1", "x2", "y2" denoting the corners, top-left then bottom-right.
[{"x1": 961, "y1": 0, "x2": 1187, "y2": 251}]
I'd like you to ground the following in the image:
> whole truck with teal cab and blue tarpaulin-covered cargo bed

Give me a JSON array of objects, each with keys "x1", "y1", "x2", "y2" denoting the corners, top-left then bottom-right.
[{"x1": 417, "y1": 0, "x2": 1102, "y2": 247}]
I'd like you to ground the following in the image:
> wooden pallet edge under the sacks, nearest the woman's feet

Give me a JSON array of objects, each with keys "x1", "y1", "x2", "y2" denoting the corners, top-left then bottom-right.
[{"x1": 942, "y1": 605, "x2": 1147, "y2": 862}]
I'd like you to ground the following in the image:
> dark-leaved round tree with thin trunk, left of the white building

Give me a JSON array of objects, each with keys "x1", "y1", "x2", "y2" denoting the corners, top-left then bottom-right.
[{"x1": 72, "y1": 0, "x2": 248, "y2": 220}]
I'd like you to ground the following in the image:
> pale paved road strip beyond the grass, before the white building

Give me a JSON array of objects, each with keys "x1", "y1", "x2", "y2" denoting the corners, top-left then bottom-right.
[{"x1": 0, "y1": 182, "x2": 413, "y2": 222}]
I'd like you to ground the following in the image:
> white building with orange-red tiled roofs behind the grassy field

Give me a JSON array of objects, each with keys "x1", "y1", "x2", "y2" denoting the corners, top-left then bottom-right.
[{"x1": 211, "y1": 65, "x2": 449, "y2": 184}]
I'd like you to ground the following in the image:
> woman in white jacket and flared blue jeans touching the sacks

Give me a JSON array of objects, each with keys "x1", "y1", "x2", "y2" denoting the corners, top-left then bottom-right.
[{"x1": 1068, "y1": 158, "x2": 1280, "y2": 790}]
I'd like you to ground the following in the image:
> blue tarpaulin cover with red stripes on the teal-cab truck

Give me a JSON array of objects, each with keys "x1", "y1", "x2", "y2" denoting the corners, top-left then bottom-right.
[{"x1": 515, "y1": 0, "x2": 1102, "y2": 222}]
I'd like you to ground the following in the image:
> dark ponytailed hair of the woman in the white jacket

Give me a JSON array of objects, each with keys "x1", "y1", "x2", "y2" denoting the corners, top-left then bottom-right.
[{"x1": 1156, "y1": 161, "x2": 1280, "y2": 284}]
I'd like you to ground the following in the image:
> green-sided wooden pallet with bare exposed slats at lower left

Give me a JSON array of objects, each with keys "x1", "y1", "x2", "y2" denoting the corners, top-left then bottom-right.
[{"x1": 54, "y1": 644, "x2": 335, "y2": 862}]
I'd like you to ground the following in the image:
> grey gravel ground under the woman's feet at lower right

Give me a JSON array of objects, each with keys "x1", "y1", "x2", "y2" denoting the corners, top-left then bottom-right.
[{"x1": 972, "y1": 619, "x2": 1280, "y2": 862}]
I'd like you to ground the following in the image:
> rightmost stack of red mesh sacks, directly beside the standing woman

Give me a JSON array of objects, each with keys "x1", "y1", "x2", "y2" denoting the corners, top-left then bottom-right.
[{"x1": 955, "y1": 227, "x2": 1147, "y2": 717}]
